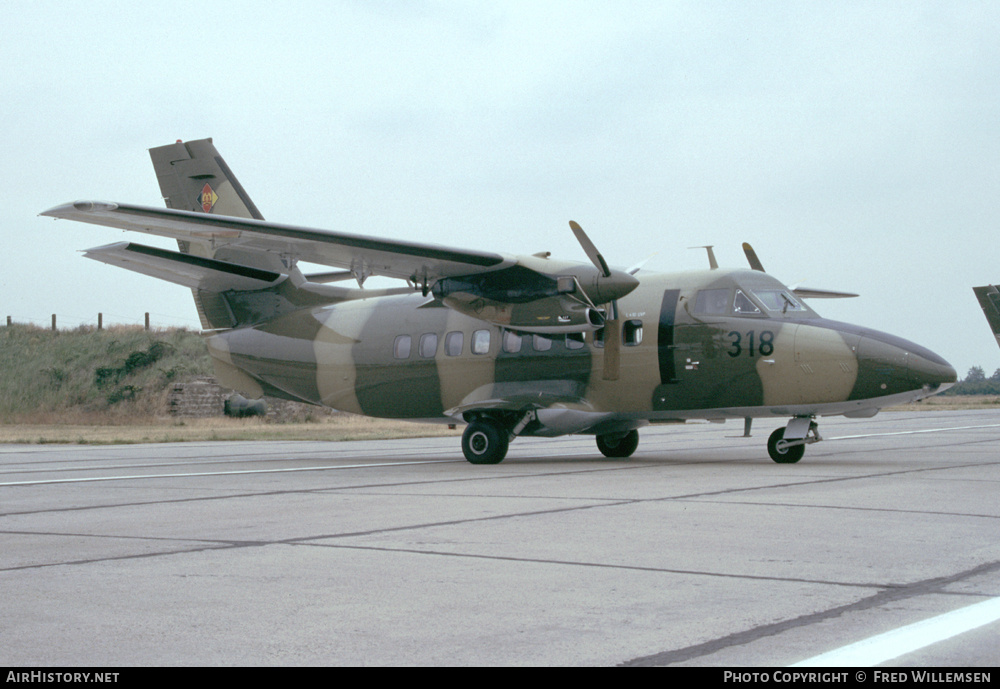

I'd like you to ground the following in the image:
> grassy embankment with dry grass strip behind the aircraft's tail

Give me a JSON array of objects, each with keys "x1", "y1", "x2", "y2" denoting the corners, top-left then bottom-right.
[{"x1": 0, "y1": 325, "x2": 455, "y2": 444}]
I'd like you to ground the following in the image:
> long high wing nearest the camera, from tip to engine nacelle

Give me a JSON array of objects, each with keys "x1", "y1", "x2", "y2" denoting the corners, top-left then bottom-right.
[{"x1": 42, "y1": 201, "x2": 508, "y2": 285}]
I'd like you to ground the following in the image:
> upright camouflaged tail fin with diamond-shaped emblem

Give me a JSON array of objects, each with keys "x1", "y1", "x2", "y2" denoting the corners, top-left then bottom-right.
[{"x1": 149, "y1": 139, "x2": 272, "y2": 330}]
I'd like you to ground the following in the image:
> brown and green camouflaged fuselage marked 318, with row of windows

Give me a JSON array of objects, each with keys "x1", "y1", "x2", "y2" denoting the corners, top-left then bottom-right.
[{"x1": 209, "y1": 270, "x2": 956, "y2": 435}]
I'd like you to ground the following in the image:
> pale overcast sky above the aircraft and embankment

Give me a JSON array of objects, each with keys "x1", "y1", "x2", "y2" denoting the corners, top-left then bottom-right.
[{"x1": 0, "y1": 0, "x2": 1000, "y2": 376}]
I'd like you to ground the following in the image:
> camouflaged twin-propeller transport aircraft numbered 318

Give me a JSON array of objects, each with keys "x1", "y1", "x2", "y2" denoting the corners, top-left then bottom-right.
[{"x1": 42, "y1": 139, "x2": 956, "y2": 464}]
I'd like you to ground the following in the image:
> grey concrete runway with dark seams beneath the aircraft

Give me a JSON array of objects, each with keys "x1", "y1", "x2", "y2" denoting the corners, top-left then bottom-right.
[{"x1": 0, "y1": 411, "x2": 1000, "y2": 667}]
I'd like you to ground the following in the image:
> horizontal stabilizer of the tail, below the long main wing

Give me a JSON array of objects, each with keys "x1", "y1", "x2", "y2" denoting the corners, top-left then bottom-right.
[{"x1": 84, "y1": 242, "x2": 285, "y2": 292}]
